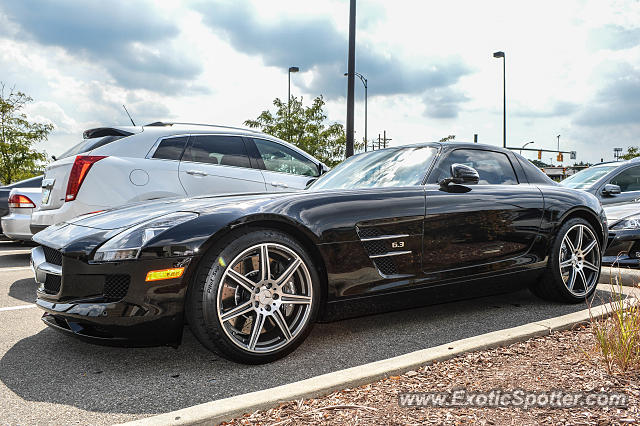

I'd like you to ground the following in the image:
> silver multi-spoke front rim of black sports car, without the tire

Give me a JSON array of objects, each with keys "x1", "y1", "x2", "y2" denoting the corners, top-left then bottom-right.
[{"x1": 216, "y1": 243, "x2": 313, "y2": 354}]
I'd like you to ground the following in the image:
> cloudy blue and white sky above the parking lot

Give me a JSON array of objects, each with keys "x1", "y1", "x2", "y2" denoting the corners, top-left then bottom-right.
[{"x1": 0, "y1": 0, "x2": 640, "y2": 163}]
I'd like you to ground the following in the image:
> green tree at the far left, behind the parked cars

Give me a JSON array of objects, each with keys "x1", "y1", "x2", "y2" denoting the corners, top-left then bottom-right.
[{"x1": 0, "y1": 82, "x2": 53, "y2": 185}]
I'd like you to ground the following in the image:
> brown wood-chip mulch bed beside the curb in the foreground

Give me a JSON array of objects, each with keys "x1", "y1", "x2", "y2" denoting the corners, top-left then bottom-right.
[{"x1": 226, "y1": 326, "x2": 640, "y2": 425}]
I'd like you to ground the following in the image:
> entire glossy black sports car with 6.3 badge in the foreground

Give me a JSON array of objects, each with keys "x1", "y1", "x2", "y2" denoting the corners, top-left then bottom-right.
[{"x1": 32, "y1": 143, "x2": 607, "y2": 363}]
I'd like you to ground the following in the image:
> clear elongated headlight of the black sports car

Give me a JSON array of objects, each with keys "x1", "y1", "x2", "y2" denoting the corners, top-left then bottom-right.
[{"x1": 93, "y1": 212, "x2": 198, "y2": 262}]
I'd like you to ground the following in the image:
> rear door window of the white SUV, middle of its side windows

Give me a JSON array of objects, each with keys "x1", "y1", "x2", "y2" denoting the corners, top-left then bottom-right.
[{"x1": 182, "y1": 135, "x2": 251, "y2": 168}]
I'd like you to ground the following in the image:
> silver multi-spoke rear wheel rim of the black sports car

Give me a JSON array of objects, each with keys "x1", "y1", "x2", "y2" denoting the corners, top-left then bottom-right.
[{"x1": 559, "y1": 224, "x2": 600, "y2": 297}]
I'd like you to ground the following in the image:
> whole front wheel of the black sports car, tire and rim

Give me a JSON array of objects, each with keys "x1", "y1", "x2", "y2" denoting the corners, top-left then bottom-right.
[{"x1": 186, "y1": 229, "x2": 320, "y2": 364}]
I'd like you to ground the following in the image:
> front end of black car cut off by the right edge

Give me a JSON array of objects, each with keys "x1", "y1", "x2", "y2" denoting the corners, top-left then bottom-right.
[{"x1": 602, "y1": 202, "x2": 640, "y2": 268}]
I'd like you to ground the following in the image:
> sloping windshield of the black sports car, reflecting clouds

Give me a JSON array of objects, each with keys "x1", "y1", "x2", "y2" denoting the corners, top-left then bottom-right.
[{"x1": 309, "y1": 146, "x2": 438, "y2": 191}]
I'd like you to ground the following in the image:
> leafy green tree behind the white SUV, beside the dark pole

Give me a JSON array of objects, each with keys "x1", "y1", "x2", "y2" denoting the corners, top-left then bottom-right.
[{"x1": 244, "y1": 96, "x2": 364, "y2": 167}]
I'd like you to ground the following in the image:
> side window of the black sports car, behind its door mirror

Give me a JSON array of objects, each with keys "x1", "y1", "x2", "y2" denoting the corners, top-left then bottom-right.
[{"x1": 428, "y1": 149, "x2": 518, "y2": 185}]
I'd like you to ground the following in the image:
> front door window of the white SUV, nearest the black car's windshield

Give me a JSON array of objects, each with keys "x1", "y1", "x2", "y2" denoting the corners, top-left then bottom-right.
[{"x1": 253, "y1": 139, "x2": 318, "y2": 177}]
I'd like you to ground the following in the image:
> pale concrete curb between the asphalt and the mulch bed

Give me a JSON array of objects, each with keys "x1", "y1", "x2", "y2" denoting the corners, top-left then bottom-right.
[{"x1": 120, "y1": 284, "x2": 637, "y2": 426}]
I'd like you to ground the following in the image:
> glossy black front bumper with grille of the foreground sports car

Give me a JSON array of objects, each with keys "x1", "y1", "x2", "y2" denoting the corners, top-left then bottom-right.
[{"x1": 31, "y1": 246, "x2": 192, "y2": 346}]
